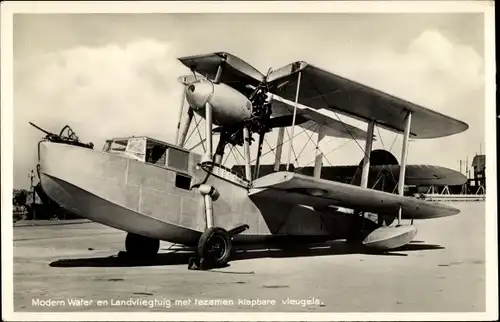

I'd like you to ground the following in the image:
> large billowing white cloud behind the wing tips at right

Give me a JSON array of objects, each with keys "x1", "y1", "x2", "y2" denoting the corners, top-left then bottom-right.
[{"x1": 294, "y1": 30, "x2": 485, "y2": 168}]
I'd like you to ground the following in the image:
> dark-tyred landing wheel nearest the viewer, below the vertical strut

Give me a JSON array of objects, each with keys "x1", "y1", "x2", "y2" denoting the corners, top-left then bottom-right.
[{"x1": 198, "y1": 227, "x2": 232, "y2": 267}]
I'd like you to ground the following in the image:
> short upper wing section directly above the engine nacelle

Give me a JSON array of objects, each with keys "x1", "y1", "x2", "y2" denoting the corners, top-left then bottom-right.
[{"x1": 178, "y1": 52, "x2": 264, "y2": 89}]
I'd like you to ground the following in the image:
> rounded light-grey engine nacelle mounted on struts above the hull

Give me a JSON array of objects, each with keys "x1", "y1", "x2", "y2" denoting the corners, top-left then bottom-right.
[{"x1": 185, "y1": 79, "x2": 252, "y2": 126}]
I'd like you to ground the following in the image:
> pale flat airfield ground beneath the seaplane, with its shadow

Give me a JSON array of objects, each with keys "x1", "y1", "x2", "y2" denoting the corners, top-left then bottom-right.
[{"x1": 14, "y1": 202, "x2": 485, "y2": 312}]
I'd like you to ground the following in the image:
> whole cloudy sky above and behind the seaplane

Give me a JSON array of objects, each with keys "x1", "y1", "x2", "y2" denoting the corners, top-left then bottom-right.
[{"x1": 14, "y1": 13, "x2": 485, "y2": 188}]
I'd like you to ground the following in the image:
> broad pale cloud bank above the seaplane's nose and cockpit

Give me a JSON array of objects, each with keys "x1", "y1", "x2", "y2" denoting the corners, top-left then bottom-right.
[{"x1": 14, "y1": 40, "x2": 185, "y2": 187}]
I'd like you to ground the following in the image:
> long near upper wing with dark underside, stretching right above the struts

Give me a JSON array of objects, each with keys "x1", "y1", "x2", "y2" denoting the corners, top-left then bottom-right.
[{"x1": 267, "y1": 61, "x2": 469, "y2": 139}]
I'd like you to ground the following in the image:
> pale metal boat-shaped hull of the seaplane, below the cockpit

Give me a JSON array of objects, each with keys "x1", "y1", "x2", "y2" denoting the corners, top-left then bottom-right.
[{"x1": 39, "y1": 142, "x2": 349, "y2": 245}]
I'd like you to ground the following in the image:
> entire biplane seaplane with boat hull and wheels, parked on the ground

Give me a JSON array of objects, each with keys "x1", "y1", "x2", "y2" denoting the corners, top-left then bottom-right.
[{"x1": 31, "y1": 52, "x2": 468, "y2": 268}]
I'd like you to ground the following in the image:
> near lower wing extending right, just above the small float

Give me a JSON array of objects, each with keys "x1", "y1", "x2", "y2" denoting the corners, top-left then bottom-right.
[{"x1": 249, "y1": 171, "x2": 460, "y2": 219}]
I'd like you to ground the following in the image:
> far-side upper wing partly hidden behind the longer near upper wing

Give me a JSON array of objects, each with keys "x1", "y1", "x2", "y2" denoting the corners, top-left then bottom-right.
[{"x1": 272, "y1": 95, "x2": 367, "y2": 140}]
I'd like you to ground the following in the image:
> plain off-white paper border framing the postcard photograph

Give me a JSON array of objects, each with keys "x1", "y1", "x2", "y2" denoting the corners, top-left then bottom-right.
[{"x1": 1, "y1": 1, "x2": 498, "y2": 321}]
